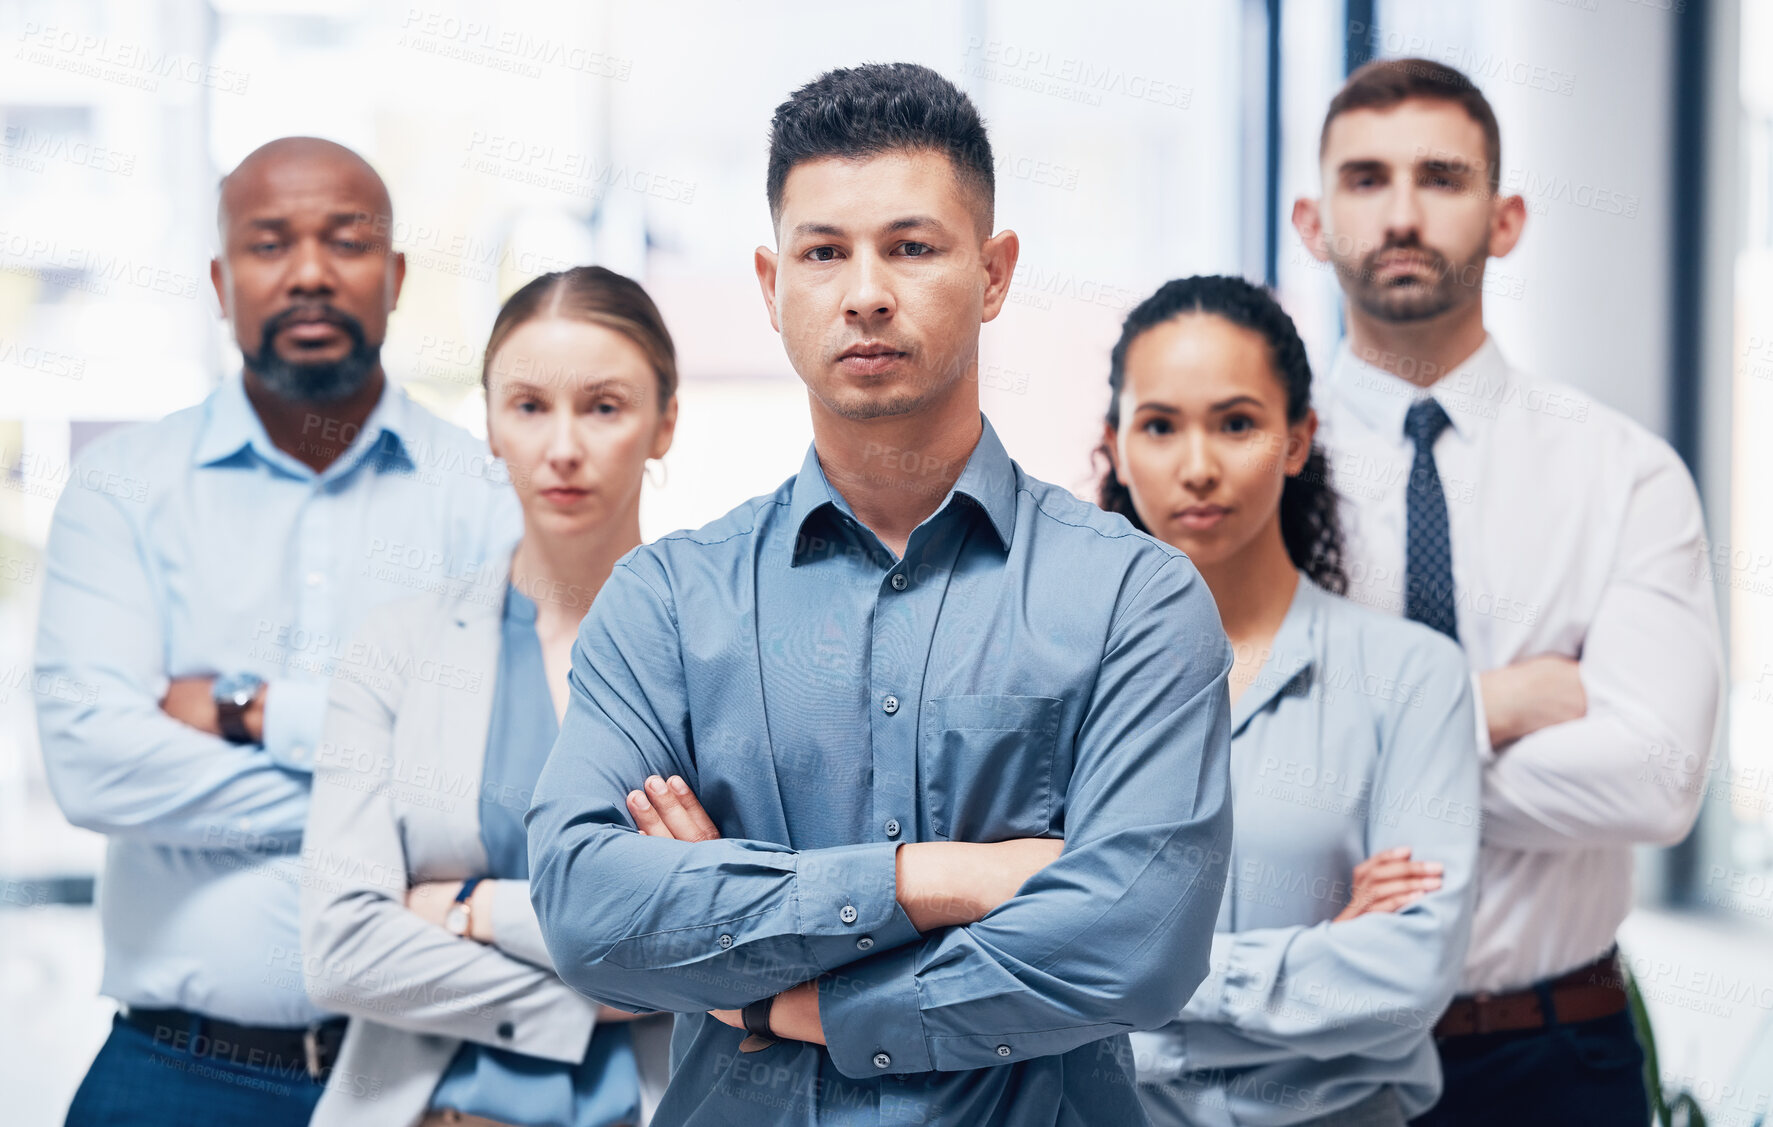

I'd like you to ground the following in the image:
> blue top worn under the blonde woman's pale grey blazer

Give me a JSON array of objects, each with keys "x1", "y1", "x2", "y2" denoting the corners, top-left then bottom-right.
[{"x1": 431, "y1": 587, "x2": 640, "y2": 1127}]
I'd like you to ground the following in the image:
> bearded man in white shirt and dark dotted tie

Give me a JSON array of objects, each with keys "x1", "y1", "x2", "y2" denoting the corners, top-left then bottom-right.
[{"x1": 1293, "y1": 58, "x2": 1722, "y2": 1127}]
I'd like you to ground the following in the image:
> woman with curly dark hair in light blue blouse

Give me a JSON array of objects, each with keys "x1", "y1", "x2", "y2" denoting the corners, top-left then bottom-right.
[{"x1": 1096, "y1": 276, "x2": 1479, "y2": 1127}]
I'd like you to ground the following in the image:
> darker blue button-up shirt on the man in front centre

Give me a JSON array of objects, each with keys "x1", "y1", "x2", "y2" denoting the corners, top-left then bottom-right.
[{"x1": 528, "y1": 422, "x2": 1230, "y2": 1127}]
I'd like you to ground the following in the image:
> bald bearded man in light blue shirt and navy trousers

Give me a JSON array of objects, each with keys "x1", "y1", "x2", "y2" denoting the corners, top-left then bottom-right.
[{"x1": 37, "y1": 136, "x2": 518, "y2": 1127}]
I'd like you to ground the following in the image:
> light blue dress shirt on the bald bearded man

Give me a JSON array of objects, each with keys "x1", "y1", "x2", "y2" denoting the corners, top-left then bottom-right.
[{"x1": 37, "y1": 374, "x2": 519, "y2": 1026}]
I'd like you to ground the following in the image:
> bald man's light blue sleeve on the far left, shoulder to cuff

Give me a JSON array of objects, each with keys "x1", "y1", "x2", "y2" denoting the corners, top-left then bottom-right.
[{"x1": 34, "y1": 468, "x2": 309, "y2": 849}]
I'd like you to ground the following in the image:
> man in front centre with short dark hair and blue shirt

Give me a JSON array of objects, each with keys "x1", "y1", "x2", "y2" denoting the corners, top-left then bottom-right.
[{"x1": 528, "y1": 64, "x2": 1230, "y2": 1127}]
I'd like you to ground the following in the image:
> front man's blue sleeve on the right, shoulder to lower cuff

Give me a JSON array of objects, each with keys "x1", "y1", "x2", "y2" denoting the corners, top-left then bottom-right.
[{"x1": 819, "y1": 558, "x2": 1230, "y2": 1077}]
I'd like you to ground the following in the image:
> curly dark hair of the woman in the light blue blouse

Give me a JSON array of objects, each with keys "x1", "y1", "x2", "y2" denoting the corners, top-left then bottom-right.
[{"x1": 1092, "y1": 275, "x2": 1347, "y2": 595}]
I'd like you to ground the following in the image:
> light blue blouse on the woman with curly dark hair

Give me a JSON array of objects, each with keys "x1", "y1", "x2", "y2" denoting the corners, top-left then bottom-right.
[{"x1": 1131, "y1": 576, "x2": 1480, "y2": 1127}]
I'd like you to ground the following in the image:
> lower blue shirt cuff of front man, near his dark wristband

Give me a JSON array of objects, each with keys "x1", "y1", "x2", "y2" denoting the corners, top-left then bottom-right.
[{"x1": 819, "y1": 944, "x2": 933, "y2": 1079}]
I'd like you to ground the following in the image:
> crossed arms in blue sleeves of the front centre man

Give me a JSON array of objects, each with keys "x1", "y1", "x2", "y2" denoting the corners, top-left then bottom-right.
[{"x1": 528, "y1": 549, "x2": 1230, "y2": 1077}]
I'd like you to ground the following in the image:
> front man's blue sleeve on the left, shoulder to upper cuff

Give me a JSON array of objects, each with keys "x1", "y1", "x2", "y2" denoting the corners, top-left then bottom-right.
[{"x1": 527, "y1": 549, "x2": 918, "y2": 1014}]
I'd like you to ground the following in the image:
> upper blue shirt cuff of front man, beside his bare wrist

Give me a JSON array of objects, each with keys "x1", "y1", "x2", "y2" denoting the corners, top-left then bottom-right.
[{"x1": 794, "y1": 842, "x2": 920, "y2": 971}]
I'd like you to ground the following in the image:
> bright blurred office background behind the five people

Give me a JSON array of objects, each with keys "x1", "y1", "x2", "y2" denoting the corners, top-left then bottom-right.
[{"x1": 0, "y1": 0, "x2": 1773, "y2": 1127}]
